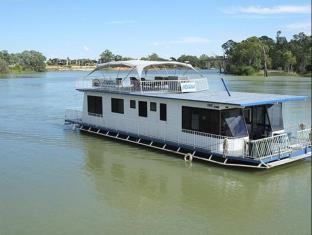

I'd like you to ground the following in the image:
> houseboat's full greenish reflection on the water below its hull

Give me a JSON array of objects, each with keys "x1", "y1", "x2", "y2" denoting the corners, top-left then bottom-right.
[{"x1": 80, "y1": 132, "x2": 311, "y2": 229}]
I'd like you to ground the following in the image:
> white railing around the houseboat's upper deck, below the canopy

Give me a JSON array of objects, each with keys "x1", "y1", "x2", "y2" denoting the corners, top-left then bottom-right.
[{"x1": 76, "y1": 78, "x2": 208, "y2": 93}]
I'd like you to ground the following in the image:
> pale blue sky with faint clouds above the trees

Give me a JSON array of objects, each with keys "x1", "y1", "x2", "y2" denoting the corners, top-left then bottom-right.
[{"x1": 0, "y1": 0, "x2": 311, "y2": 59}]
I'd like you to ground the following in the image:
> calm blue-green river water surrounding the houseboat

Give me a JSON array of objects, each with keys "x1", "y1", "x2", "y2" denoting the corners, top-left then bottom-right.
[{"x1": 0, "y1": 71, "x2": 311, "y2": 235}]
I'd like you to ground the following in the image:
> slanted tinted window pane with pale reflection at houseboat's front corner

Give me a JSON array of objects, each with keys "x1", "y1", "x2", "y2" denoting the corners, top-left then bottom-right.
[{"x1": 221, "y1": 109, "x2": 248, "y2": 137}]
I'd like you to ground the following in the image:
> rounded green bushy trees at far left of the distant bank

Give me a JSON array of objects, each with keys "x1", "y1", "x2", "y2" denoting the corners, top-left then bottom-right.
[{"x1": 0, "y1": 50, "x2": 46, "y2": 73}]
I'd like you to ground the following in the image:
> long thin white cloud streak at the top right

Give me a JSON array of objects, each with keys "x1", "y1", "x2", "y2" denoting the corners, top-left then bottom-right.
[{"x1": 222, "y1": 5, "x2": 311, "y2": 15}]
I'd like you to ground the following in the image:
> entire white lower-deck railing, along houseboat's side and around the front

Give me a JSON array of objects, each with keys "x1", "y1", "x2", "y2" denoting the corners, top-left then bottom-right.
[{"x1": 65, "y1": 110, "x2": 312, "y2": 160}]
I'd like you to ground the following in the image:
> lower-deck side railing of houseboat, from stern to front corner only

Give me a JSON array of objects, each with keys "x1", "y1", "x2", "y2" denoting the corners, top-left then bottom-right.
[{"x1": 65, "y1": 110, "x2": 248, "y2": 156}]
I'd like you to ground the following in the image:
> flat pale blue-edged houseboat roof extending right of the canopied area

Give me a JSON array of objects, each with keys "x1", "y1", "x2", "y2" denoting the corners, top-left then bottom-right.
[{"x1": 131, "y1": 90, "x2": 308, "y2": 107}]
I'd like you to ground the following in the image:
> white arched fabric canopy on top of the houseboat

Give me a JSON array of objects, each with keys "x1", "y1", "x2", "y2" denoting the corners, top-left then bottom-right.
[{"x1": 91, "y1": 60, "x2": 196, "y2": 78}]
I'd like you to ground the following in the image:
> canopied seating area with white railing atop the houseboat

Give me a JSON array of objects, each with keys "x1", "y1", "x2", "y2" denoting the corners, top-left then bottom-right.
[{"x1": 76, "y1": 60, "x2": 208, "y2": 93}]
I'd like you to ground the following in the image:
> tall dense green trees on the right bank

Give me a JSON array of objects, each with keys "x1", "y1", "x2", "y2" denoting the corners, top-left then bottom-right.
[{"x1": 222, "y1": 31, "x2": 312, "y2": 75}]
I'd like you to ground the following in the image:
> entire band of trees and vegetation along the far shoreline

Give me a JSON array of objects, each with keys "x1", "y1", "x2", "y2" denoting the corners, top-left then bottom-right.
[{"x1": 0, "y1": 31, "x2": 312, "y2": 76}]
